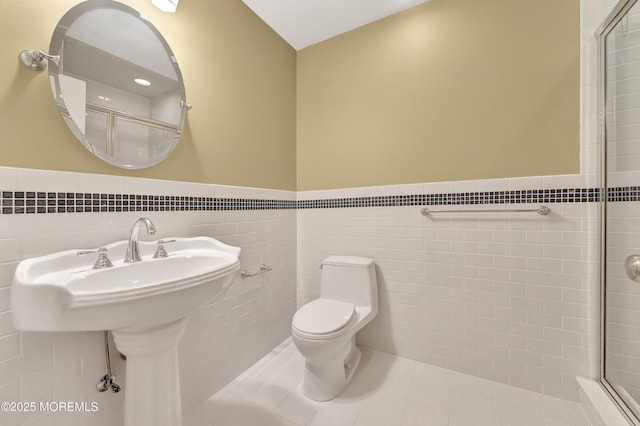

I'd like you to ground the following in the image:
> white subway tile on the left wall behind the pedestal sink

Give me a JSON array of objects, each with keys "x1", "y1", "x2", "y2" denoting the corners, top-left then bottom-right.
[{"x1": 0, "y1": 168, "x2": 296, "y2": 425}]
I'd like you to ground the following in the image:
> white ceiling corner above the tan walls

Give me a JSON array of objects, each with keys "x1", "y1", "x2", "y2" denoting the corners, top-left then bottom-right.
[{"x1": 242, "y1": 0, "x2": 428, "y2": 50}]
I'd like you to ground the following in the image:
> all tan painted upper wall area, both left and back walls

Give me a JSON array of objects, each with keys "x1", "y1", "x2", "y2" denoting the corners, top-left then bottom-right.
[{"x1": 0, "y1": 0, "x2": 579, "y2": 190}]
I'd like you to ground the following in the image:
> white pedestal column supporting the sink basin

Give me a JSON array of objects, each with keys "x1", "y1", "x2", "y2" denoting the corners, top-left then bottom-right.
[{"x1": 112, "y1": 318, "x2": 187, "y2": 426}]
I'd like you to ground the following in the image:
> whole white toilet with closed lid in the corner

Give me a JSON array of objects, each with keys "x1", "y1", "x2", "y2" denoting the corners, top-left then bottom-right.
[{"x1": 291, "y1": 256, "x2": 378, "y2": 401}]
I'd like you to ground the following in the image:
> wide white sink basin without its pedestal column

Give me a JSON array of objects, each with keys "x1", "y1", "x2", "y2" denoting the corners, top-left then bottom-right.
[{"x1": 11, "y1": 237, "x2": 240, "y2": 331}]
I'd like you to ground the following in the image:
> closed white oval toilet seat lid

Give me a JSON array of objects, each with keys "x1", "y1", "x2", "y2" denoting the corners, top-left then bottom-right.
[{"x1": 291, "y1": 298, "x2": 357, "y2": 339}]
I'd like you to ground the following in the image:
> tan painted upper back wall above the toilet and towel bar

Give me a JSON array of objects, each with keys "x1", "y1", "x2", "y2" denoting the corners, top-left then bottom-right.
[{"x1": 297, "y1": 0, "x2": 580, "y2": 190}]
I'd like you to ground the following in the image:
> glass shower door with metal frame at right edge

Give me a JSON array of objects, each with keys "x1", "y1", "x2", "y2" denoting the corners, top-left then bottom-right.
[{"x1": 599, "y1": 0, "x2": 640, "y2": 424}]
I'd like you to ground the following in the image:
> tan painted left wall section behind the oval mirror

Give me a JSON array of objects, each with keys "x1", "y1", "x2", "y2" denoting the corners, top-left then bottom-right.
[{"x1": 0, "y1": 0, "x2": 296, "y2": 190}]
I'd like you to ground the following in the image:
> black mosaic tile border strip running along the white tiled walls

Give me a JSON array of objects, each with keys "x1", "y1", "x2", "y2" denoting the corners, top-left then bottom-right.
[{"x1": 0, "y1": 186, "x2": 640, "y2": 215}]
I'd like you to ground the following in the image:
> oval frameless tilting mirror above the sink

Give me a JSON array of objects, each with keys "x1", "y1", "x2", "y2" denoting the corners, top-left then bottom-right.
[{"x1": 49, "y1": 0, "x2": 189, "y2": 169}]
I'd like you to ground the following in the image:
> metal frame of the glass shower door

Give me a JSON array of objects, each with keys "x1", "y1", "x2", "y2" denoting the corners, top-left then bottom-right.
[{"x1": 594, "y1": 0, "x2": 640, "y2": 426}]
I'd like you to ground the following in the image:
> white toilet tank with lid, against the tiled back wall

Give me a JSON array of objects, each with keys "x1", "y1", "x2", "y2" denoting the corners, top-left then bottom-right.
[{"x1": 320, "y1": 256, "x2": 378, "y2": 311}]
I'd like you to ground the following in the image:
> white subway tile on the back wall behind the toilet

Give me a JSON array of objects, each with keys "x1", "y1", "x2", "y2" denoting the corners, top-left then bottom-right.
[{"x1": 298, "y1": 181, "x2": 598, "y2": 401}]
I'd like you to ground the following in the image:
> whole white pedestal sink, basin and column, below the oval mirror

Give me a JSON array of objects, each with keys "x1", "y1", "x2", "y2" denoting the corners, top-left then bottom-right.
[{"x1": 11, "y1": 237, "x2": 240, "y2": 426}]
